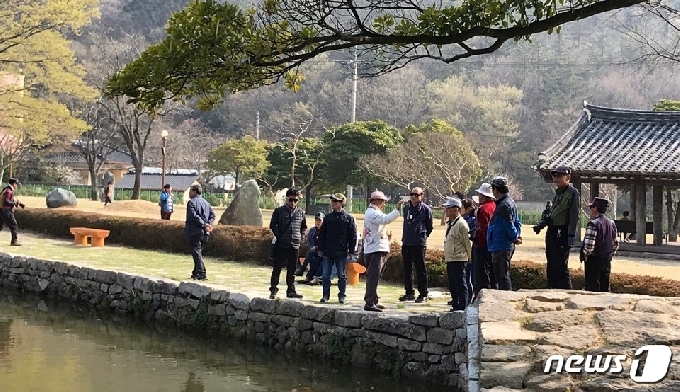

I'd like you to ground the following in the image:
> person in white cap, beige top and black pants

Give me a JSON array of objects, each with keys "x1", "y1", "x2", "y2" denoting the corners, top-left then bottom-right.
[{"x1": 443, "y1": 197, "x2": 472, "y2": 311}]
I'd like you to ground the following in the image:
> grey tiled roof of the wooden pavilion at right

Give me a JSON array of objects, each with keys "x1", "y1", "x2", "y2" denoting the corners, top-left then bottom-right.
[{"x1": 535, "y1": 104, "x2": 680, "y2": 179}]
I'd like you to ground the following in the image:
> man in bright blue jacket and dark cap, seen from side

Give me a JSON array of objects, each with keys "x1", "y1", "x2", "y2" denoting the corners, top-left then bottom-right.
[{"x1": 486, "y1": 177, "x2": 522, "y2": 291}]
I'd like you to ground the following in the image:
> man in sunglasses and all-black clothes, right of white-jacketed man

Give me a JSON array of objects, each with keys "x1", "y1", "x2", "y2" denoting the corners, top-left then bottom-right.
[{"x1": 399, "y1": 187, "x2": 433, "y2": 303}]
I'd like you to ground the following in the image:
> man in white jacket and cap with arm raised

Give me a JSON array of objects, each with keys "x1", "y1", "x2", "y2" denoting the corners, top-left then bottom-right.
[{"x1": 363, "y1": 190, "x2": 404, "y2": 312}]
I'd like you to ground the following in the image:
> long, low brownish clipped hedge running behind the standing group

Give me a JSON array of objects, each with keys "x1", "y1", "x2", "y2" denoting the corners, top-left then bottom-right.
[{"x1": 16, "y1": 209, "x2": 680, "y2": 297}]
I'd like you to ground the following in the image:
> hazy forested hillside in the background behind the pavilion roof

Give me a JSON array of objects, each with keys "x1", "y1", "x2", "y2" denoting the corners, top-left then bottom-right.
[{"x1": 75, "y1": 0, "x2": 680, "y2": 200}]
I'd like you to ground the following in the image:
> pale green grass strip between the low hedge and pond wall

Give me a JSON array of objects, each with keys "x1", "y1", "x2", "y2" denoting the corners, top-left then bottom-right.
[{"x1": 0, "y1": 231, "x2": 450, "y2": 313}]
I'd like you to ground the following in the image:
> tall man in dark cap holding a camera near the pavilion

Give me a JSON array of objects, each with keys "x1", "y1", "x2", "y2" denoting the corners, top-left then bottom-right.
[{"x1": 534, "y1": 166, "x2": 581, "y2": 290}]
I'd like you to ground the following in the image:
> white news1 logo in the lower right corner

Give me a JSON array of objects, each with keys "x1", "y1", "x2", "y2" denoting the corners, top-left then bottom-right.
[{"x1": 543, "y1": 345, "x2": 673, "y2": 384}]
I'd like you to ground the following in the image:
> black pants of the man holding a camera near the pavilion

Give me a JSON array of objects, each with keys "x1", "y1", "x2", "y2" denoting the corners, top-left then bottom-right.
[{"x1": 545, "y1": 226, "x2": 573, "y2": 290}]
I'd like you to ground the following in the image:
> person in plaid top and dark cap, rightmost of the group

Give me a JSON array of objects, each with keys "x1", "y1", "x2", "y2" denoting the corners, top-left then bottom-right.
[{"x1": 580, "y1": 197, "x2": 619, "y2": 292}]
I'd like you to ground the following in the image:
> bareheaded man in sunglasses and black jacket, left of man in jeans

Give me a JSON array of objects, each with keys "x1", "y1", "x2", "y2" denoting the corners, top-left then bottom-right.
[{"x1": 269, "y1": 188, "x2": 307, "y2": 299}]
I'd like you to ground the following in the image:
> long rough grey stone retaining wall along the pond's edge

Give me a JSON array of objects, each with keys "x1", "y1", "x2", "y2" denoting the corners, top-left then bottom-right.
[{"x1": 0, "y1": 254, "x2": 468, "y2": 391}]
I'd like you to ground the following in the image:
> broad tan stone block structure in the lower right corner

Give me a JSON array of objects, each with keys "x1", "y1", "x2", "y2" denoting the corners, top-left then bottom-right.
[{"x1": 468, "y1": 290, "x2": 680, "y2": 392}]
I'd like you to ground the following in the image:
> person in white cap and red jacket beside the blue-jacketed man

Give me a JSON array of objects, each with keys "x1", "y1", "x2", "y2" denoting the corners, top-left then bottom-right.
[{"x1": 472, "y1": 182, "x2": 497, "y2": 298}]
